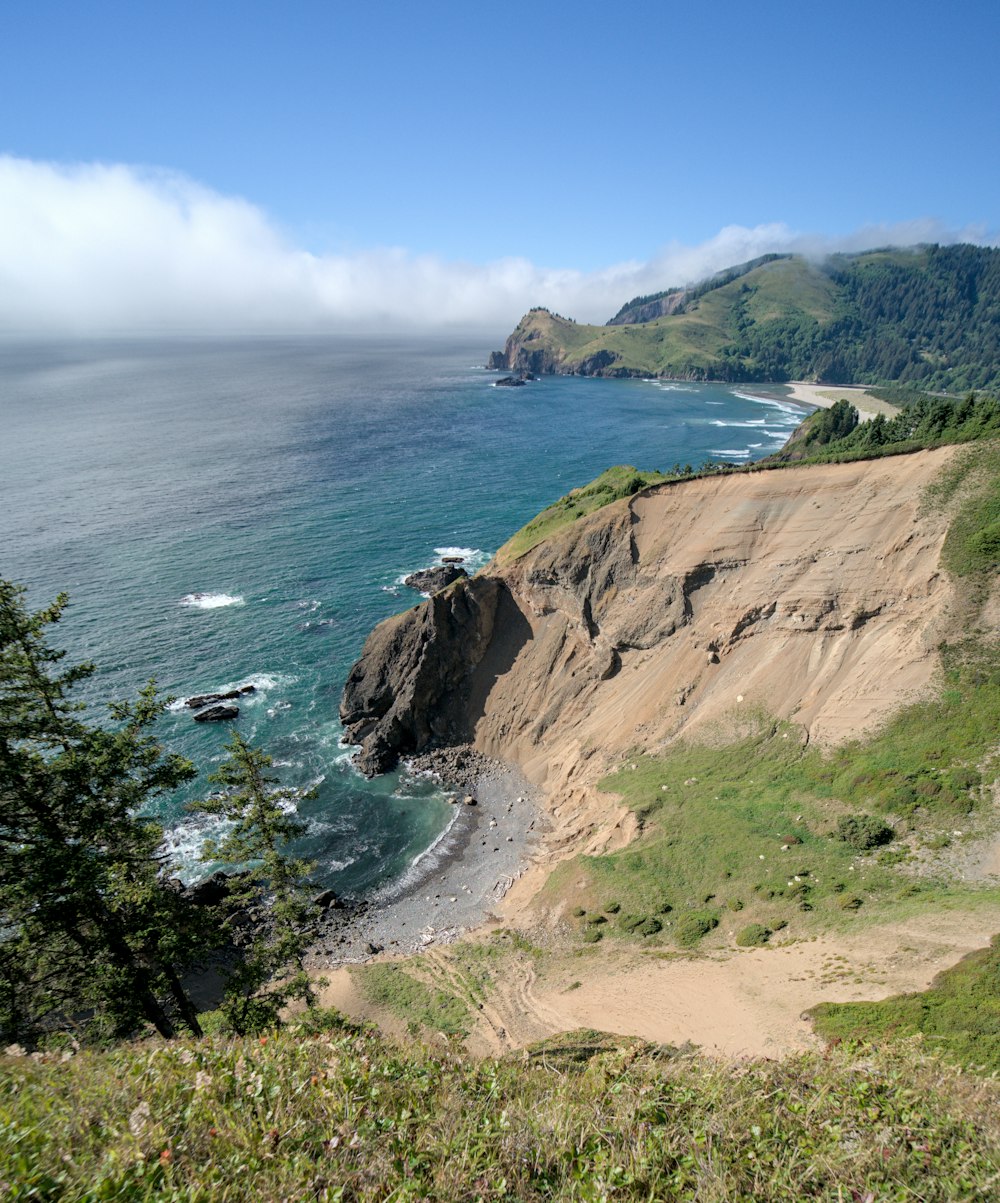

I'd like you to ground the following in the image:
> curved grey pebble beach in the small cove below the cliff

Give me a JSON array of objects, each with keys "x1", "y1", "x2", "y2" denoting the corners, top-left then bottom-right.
[{"x1": 309, "y1": 746, "x2": 545, "y2": 971}]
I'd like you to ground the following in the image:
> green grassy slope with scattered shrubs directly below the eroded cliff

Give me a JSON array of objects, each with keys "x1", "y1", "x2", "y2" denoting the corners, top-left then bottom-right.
[{"x1": 546, "y1": 640, "x2": 1000, "y2": 947}]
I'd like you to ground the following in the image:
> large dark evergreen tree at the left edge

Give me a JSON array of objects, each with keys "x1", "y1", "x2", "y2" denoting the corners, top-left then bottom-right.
[{"x1": 0, "y1": 580, "x2": 205, "y2": 1039}]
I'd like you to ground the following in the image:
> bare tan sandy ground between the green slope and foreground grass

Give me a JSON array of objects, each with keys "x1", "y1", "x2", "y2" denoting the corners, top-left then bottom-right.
[{"x1": 323, "y1": 908, "x2": 998, "y2": 1057}]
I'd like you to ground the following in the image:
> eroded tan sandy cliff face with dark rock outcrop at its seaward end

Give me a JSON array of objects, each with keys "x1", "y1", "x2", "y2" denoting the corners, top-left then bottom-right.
[{"x1": 342, "y1": 449, "x2": 952, "y2": 789}]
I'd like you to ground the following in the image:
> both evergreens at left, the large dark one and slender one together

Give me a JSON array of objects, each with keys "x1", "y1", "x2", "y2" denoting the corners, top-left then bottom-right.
[{"x1": 0, "y1": 580, "x2": 314, "y2": 1043}]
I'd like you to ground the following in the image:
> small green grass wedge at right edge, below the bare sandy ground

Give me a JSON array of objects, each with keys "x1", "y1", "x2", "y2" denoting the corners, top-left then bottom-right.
[{"x1": 811, "y1": 936, "x2": 1000, "y2": 1073}]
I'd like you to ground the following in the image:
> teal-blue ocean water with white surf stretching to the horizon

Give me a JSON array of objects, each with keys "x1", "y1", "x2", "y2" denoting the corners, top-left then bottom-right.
[{"x1": 0, "y1": 338, "x2": 804, "y2": 895}]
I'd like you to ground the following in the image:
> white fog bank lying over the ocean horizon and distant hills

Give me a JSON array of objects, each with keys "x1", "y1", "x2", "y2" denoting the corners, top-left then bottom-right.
[{"x1": 0, "y1": 156, "x2": 988, "y2": 333}]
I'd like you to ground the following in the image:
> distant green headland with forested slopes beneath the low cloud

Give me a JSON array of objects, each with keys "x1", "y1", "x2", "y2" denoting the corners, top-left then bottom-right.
[{"x1": 493, "y1": 245, "x2": 1000, "y2": 391}]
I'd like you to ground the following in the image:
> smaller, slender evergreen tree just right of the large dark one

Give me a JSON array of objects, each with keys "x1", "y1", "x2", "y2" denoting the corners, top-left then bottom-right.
[{"x1": 191, "y1": 730, "x2": 315, "y2": 1035}]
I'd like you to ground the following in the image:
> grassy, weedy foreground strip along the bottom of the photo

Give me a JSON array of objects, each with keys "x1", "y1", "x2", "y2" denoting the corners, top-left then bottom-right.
[{"x1": 0, "y1": 1014, "x2": 1000, "y2": 1203}]
